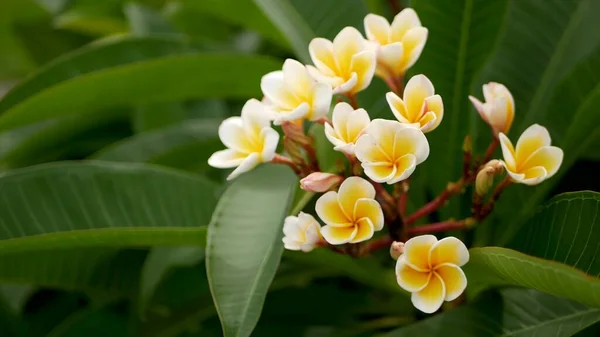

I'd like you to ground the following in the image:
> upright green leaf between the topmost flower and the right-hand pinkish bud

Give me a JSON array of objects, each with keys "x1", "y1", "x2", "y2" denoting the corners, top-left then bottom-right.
[{"x1": 408, "y1": 0, "x2": 508, "y2": 207}]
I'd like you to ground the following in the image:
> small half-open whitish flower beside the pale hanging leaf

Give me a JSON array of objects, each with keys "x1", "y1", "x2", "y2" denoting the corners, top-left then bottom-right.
[{"x1": 283, "y1": 212, "x2": 321, "y2": 252}]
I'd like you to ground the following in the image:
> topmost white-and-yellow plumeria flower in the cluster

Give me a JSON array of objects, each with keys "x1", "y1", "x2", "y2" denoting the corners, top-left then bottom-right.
[{"x1": 364, "y1": 8, "x2": 428, "y2": 78}]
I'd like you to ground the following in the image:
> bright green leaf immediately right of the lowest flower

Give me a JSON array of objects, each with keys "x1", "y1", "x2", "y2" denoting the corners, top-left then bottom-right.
[{"x1": 464, "y1": 247, "x2": 600, "y2": 307}]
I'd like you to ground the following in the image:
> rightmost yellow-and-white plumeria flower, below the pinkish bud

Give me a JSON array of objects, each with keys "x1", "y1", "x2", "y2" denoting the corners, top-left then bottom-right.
[{"x1": 499, "y1": 124, "x2": 563, "y2": 185}]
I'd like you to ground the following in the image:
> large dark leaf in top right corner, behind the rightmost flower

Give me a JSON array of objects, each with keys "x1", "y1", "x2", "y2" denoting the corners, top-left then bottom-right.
[{"x1": 474, "y1": 0, "x2": 600, "y2": 245}]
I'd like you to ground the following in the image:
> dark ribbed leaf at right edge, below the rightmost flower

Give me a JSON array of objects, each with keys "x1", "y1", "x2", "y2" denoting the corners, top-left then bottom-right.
[{"x1": 508, "y1": 192, "x2": 600, "y2": 277}]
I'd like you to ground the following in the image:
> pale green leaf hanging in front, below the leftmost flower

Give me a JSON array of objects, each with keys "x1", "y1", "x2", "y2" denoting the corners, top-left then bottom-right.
[{"x1": 206, "y1": 166, "x2": 297, "y2": 336}]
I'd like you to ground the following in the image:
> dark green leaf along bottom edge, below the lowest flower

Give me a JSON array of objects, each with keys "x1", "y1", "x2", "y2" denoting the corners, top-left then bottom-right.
[{"x1": 385, "y1": 289, "x2": 600, "y2": 337}]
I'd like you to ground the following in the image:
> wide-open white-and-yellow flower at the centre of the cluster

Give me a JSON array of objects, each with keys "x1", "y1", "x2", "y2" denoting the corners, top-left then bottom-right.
[{"x1": 354, "y1": 119, "x2": 429, "y2": 184}]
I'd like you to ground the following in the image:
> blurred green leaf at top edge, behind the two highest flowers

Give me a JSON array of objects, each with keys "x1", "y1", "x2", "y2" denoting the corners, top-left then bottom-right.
[{"x1": 254, "y1": 0, "x2": 367, "y2": 63}]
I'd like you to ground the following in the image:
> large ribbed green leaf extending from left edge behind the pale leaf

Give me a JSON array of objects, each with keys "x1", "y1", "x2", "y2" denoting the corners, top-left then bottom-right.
[{"x1": 0, "y1": 162, "x2": 217, "y2": 293}]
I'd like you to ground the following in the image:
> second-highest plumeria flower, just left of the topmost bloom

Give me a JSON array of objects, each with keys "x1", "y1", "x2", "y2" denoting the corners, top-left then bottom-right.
[{"x1": 307, "y1": 27, "x2": 377, "y2": 94}]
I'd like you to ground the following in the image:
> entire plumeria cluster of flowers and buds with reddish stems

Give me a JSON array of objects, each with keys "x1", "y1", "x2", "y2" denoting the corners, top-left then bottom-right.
[{"x1": 209, "y1": 8, "x2": 563, "y2": 313}]
